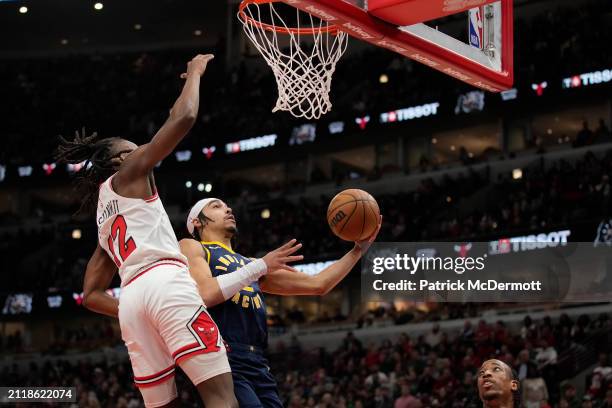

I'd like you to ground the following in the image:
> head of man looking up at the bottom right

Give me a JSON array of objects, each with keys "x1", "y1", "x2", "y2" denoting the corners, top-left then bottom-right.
[{"x1": 478, "y1": 360, "x2": 518, "y2": 408}]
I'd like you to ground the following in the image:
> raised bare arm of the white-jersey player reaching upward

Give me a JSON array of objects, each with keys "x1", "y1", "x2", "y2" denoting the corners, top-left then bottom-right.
[{"x1": 117, "y1": 54, "x2": 214, "y2": 184}]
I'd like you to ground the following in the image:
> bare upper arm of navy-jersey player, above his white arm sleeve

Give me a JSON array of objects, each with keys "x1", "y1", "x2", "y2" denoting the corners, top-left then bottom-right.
[{"x1": 179, "y1": 238, "x2": 225, "y2": 307}]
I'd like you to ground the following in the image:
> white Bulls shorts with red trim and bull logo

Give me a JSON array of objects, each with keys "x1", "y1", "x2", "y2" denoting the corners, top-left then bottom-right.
[{"x1": 119, "y1": 264, "x2": 231, "y2": 407}]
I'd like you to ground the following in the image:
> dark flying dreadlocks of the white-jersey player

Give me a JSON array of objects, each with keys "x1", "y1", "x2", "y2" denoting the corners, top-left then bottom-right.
[{"x1": 54, "y1": 128, "x2": 121, "y2": 215}]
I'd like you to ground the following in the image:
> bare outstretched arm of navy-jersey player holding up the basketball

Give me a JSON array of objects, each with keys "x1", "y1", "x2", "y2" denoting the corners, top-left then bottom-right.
[{"x1": 259, "y1": 217, "x2": 382, "y2": 296}]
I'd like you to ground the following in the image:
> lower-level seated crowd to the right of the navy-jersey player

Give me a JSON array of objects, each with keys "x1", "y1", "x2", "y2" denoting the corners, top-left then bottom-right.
[{"x1": 271, "y1": 315, "x2": 612, "y2": 408}]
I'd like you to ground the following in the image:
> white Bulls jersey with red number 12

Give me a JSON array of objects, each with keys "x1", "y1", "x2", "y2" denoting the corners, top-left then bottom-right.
[{"x1": 96, "y1": 177, "x2": 187, "y2": 286}]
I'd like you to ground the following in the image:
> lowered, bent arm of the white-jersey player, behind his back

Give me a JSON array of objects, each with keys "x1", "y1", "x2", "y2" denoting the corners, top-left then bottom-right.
[{"x1": 83, "y1": 245, "x2": 119, "y2": 317}]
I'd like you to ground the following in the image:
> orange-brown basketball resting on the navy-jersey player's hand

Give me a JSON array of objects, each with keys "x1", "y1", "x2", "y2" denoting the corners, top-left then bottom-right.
[{"x1": 327, "y1": 189, "x2": 380, "y2": 241}]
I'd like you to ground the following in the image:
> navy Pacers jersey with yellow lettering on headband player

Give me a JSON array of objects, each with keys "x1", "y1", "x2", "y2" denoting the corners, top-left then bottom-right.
[{"x1": 202, "y1": 242, "x2": 268, "y2": 349}]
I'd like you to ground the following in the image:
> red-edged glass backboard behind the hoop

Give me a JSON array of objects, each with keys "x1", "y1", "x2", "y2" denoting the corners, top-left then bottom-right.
[{"x1": 280, "y1": 0, "x2": 514, "y2": 92}]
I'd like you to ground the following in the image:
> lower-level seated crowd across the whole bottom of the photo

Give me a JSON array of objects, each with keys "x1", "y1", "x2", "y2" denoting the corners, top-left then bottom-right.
[{"x1": 0, "y1": 314, "x2": 612, "y2": 408}]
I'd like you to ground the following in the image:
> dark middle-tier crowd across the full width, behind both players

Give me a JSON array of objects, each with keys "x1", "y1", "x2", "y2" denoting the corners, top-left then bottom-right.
[{"x1": 0, "y1": 151, "x2": 612, "y2": 292}]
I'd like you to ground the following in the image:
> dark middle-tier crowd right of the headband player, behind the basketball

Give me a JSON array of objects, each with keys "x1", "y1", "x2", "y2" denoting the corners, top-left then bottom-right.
[{"x1": 230, "y1": 151, "x2": 612, "y2": 256}]
